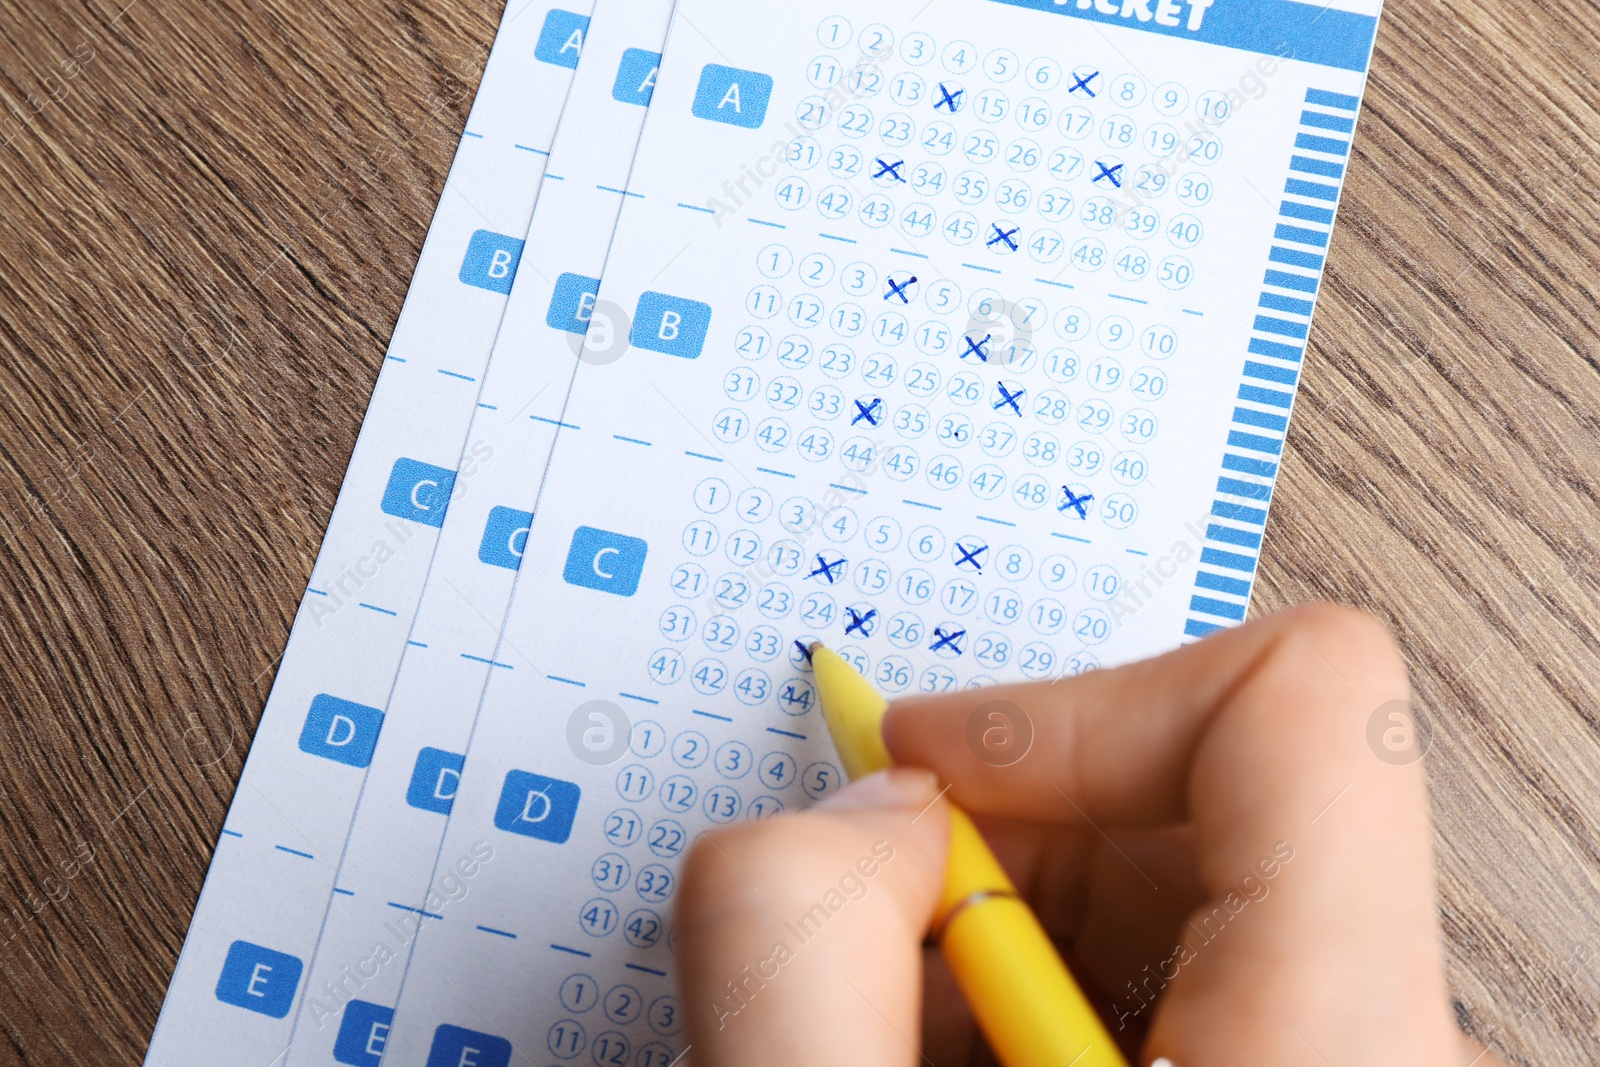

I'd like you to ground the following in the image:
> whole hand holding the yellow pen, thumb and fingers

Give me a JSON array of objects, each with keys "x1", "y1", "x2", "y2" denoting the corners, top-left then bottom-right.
[{"x1": 677, "y1": 605, "x2": 1499, "y2": 1067}]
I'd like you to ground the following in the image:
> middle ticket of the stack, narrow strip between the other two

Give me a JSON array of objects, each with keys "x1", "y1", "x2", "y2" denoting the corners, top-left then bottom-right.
[{"x1": 278, "y1": 0, "x2": 672, "y2": 1067}]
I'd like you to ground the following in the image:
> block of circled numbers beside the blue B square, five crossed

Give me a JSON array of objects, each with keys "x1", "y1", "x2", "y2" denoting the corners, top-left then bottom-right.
[{"x1": 726, "y1": 243, "x2": 1178, "y2": 530}]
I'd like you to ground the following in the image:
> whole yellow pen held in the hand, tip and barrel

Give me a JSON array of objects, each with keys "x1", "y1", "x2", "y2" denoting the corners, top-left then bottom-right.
[{"x1": 811, "y1": 643, "x2": 1128, "y2": 1067}]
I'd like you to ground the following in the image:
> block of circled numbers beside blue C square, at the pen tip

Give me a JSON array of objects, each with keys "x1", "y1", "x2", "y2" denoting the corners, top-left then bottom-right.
[{"x1": 656, "y1": 477, "x2": 1126, "y2": 700}]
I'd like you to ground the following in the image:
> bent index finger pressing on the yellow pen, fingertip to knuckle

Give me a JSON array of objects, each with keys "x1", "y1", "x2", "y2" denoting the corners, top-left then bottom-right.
[{"x1": 883, "y1": 605, "x2": 1421, "y2": 825}]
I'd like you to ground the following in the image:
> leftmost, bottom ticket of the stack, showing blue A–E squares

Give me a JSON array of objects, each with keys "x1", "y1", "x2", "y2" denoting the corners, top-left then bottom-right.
[{"x1": 146, "y1": 0, "x2": 587, "y2": 1065}]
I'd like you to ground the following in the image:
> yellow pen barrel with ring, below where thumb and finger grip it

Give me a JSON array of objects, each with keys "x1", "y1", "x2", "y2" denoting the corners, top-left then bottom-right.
[{"x1": 934, "y1": 808, "x2": 1128, "y2": 1067}]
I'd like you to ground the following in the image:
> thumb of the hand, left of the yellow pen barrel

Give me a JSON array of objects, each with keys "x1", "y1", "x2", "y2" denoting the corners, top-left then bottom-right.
[{"x1": 678, "y1": 769, "x2": 949, "y2": 1067}]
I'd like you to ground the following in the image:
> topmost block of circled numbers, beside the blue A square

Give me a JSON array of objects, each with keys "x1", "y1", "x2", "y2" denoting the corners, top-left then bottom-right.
[{"x1": 773, "y1": 19, "x2": 1227, "y2": 290}]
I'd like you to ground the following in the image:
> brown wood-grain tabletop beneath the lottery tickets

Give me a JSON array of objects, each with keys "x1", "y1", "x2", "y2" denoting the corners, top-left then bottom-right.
[{"x1": 0, "y1": 0, "x2": 1600, "y2": 1065}]
